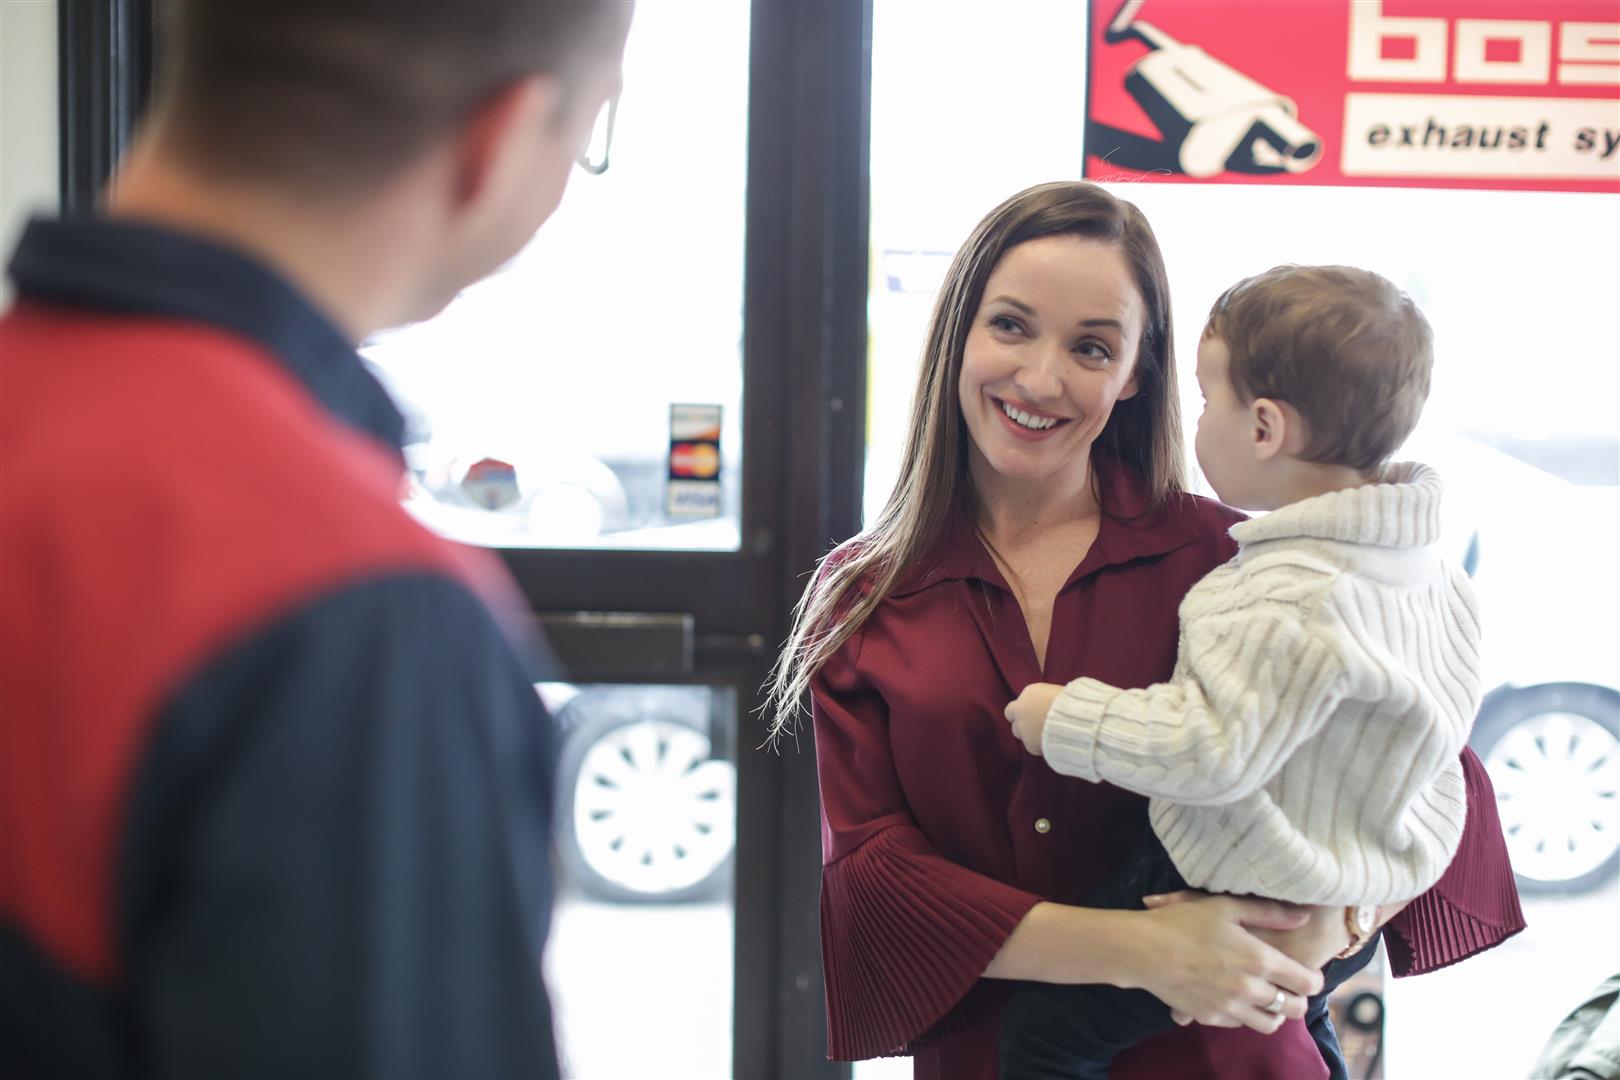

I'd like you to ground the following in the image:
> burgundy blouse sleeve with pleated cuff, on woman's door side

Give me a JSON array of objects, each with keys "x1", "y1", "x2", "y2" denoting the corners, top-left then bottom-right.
[{"x1": 812, "y1": 628, "x2": 1040, "y2": 1061}]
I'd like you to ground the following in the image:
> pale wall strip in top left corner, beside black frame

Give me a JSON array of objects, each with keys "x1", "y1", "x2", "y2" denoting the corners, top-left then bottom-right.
[{"x1": 0, "y1": 0, "x2": 60, "y2": 304}]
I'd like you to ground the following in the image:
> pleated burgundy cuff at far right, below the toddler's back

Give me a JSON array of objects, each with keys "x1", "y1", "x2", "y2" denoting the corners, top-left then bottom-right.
[{"x1": 1383, "y1": 751, "x2": 1524, "y2": 976}]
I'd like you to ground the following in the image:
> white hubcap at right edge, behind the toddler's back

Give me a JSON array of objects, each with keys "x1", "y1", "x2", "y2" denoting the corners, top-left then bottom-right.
[{"x1": 1486, "y1": 712, "x2": 1620, "y2": 881}]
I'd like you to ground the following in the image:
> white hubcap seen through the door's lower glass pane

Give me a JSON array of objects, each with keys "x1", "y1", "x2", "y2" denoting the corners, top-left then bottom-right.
[{"x1": 573, "y1": 721, "x2": 737, "y2": 897}]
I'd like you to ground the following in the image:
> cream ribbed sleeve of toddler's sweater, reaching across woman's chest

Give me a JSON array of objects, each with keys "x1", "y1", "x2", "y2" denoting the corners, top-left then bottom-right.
[{"x1": 1042, "y1": 594, "x2": 1343, "y2": 805}]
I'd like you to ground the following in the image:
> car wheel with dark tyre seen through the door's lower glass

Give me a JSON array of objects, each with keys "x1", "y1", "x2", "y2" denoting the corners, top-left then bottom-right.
[{"x1": 557, "y1": 695, "x2": 737, "y2": 904}]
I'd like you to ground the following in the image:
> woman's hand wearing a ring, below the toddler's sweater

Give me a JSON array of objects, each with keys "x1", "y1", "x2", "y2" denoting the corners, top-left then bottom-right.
[{"x1": 1121, "y1": 894, "x2": 1322, "y2": 1035}]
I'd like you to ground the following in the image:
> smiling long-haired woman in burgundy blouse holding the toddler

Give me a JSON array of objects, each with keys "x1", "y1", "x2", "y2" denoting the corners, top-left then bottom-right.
[{"x1": 774, "y1": 183, "x2": 1523, "y2": 1078}]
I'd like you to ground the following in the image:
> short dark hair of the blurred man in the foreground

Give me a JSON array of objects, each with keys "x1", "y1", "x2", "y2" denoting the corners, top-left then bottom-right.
[{"x1": 159, "y1": 0, "x2": 632, "y2": 193}]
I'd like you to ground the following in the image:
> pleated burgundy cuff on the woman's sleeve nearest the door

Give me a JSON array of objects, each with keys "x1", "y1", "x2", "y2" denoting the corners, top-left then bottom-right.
[{"x1": 821, "y1": 826, "x2": 1040, "y2": 1061}]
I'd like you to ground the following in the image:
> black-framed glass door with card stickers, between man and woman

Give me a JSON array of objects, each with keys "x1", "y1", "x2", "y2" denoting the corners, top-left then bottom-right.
[{"x1": 361, "y1": 0, "x2": 867, "y2": 1077}]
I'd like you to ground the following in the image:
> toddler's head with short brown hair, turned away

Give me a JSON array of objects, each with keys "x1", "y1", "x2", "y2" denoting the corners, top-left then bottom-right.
[{"x1": 1196, "y1": 266, "x2": 1434, "y2": 510}]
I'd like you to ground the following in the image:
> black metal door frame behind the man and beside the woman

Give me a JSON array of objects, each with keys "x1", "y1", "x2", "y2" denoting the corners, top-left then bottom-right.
[{"x1": 58, "y1": 0, "x2": 872, "y2": 1078}]
